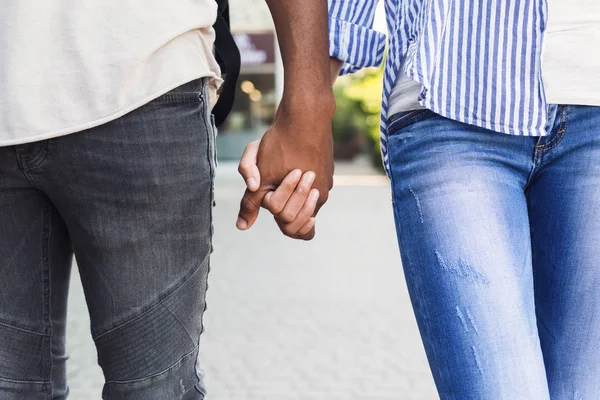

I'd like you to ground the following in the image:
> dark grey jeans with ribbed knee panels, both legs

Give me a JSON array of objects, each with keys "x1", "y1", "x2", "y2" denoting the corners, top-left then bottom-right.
[{"x1": 0, "y1": 80, "x2": 215, "y2": 400}]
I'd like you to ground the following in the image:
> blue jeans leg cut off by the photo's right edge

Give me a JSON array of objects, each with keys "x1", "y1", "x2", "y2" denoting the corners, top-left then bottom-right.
[{"x1": 527, "y1": 106, "x2": 600, "y2": 400}]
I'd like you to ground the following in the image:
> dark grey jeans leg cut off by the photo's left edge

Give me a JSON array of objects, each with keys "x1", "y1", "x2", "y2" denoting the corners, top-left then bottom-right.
[{"x1": 0, "y1": 144, "x2": 72, "y2": 400}]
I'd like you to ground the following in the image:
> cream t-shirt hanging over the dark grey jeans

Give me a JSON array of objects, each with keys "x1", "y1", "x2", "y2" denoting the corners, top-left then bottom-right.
[{"x1": 0, "y1": 0, "x2": 220, "y2": 146}]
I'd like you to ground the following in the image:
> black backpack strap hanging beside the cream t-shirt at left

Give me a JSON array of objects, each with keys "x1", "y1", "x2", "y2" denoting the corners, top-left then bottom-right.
[{"x1": 212, "y1": 0, "x2": 241, "y2": 126}]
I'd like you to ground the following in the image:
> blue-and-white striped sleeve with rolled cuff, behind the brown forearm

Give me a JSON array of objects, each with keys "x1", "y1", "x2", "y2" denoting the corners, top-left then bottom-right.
[{"x1": 329, "y1": 0, "x2": 385, "y2": 75}]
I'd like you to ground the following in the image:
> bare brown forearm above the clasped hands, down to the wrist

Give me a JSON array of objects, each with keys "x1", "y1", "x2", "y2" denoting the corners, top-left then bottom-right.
[{"x1": 266, "y1": 0, "x2": 334, "y2": 110}]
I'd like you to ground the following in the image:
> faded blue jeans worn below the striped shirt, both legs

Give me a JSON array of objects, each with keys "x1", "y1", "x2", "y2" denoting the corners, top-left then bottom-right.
[{"x1": 389, "y1": 106, "x2": 600, "y2": 400}]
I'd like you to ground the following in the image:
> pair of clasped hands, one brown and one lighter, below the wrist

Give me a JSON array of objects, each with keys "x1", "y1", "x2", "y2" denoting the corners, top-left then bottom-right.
[{"x1": 237, "y1": 95, "x2": 335, "y2": 240}]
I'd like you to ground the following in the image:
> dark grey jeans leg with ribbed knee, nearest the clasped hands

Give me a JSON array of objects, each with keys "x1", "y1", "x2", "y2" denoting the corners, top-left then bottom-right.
[{"x1": 38, "y1": 81, "x2": 214, "y2": 400}]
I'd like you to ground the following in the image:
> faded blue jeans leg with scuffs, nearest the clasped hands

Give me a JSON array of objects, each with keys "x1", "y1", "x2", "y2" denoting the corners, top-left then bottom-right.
[{"x1": 389, "y1": 111, "x2": 548, "y2": 400}]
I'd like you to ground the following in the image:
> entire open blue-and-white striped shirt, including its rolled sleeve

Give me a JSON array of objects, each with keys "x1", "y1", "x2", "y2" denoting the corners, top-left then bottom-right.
[{"x1": 329, "y1": 0, "x2": 547, "y2": 170}]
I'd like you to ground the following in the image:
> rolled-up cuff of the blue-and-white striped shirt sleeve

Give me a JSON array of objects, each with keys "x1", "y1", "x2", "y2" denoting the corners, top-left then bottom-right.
[{"x1": 329, "y1": 17, "x2": 386, "y2": 75}]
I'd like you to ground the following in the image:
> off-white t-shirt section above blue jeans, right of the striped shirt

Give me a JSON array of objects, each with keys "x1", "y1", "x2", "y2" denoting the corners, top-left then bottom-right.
[{"x1": 542, "y1": 0, "x2": 600, "y2": 106}]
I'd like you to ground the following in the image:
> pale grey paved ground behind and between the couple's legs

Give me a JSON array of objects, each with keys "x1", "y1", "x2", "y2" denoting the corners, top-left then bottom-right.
[{"x1": 68, "y1": 164, "x2": 438, "y2": 400}]
